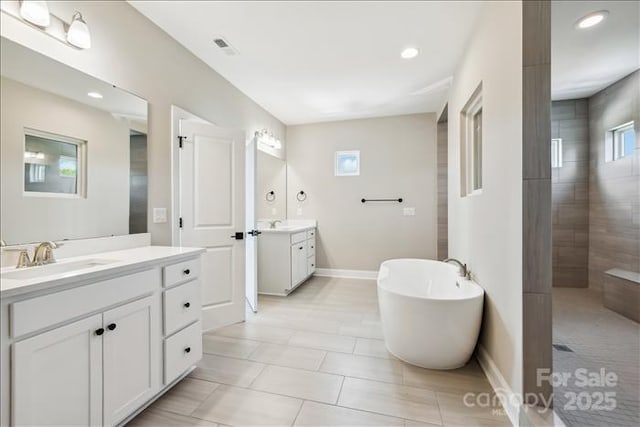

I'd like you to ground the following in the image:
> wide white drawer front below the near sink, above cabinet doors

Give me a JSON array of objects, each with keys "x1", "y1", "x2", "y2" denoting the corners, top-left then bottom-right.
[{"x1": 9, "y1": 269, "x2": 161, "y2": 338}]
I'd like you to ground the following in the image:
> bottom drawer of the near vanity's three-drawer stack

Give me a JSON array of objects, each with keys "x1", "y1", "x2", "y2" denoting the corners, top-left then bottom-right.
[{"x1": 164, "y1": 321, "x2": 202, "y2": 384}]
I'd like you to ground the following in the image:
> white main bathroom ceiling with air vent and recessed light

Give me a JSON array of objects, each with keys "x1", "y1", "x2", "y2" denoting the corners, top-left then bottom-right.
[{"x1": 129, "y1": 1, "x2": 482, "y2": 125}]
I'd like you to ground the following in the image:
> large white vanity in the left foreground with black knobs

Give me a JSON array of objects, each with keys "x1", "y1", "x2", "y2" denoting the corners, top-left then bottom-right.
[{"x1": 0, "y1": 246, "x2": 203, "y2": 426}]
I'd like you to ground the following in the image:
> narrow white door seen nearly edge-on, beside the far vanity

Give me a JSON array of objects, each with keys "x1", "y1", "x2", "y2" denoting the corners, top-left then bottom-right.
[{"x1": 245, "y1": 137, "x2": 258, "y2": 313}]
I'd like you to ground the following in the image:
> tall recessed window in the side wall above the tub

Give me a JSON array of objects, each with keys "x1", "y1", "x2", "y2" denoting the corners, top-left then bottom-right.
[{"x1": 460, "y1": 83, "x2": 483, "y2": 196}]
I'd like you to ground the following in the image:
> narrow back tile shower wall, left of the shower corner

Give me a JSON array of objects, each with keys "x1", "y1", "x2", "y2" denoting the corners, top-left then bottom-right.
[{"x1": 551, "y1": 99, "x2": 589, "y2": 288}]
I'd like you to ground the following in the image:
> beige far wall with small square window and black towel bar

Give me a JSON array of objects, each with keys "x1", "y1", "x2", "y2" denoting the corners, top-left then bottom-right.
[{"x1": 287, "y1": 114, "x2": 436, "y2": 270}]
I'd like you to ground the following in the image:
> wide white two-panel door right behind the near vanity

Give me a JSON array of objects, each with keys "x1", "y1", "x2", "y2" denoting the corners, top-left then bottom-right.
[{"x1": 178, "y1": 120, "x2": 245, "y2": 330}]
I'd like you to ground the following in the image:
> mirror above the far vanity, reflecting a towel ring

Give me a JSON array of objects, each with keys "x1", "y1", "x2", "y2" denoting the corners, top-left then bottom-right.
[{"x1": 256, "y1": 150, "x2": 287, "y2": 219}]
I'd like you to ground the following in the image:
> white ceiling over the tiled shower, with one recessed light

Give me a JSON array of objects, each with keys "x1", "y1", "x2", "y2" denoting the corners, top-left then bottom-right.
[{"x1": 551, "y1": 1, "x2": 640, "y2": 100}]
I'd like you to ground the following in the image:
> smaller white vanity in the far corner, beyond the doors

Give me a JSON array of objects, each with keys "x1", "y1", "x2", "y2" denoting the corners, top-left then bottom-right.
[{"x1": 258, "y1": 221, "x2": 316, "y2": 296}]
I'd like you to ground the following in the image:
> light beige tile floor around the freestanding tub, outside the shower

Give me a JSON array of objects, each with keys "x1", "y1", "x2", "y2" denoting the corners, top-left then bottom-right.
[{"x1": 129, "y1": 277, "x2": 510, "y2": 427}]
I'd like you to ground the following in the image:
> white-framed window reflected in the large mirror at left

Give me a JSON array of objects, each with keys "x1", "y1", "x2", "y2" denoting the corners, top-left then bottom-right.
[{"x1": 24, "y1": 129, "x2": 85, "y2": 197}]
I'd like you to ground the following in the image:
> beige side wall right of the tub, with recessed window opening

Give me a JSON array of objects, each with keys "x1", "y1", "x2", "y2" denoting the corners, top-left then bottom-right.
[{"x1": 448, "y1": 2, "x2": 523, "y2": 393}]
